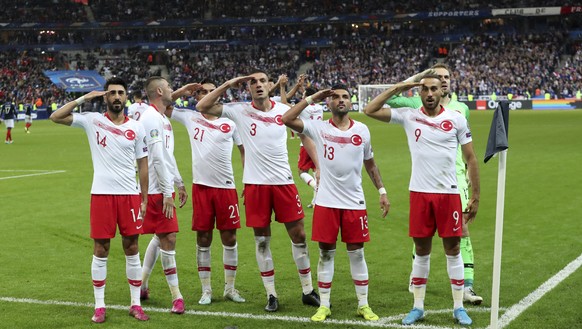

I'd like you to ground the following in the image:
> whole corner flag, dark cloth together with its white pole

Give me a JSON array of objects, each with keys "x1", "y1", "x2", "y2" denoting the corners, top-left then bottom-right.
[{"x1": 484, "y1": 101, "x2": 509, "y2": 329}]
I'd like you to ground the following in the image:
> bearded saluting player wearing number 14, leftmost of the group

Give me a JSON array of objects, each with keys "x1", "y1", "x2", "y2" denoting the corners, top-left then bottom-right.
[{"x1": 50, "y1": 78, "x2": 148, "y2": 323}]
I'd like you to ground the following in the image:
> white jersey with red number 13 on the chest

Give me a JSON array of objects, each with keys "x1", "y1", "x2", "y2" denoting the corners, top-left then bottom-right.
[{"x1": 302, "y1": 119, "x2": 374, "y2": 210}]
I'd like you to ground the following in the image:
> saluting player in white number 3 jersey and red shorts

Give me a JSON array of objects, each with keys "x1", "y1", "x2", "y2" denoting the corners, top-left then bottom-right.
[{"x1": 196, "y1": 70, "x2": 319, "y2": 312}]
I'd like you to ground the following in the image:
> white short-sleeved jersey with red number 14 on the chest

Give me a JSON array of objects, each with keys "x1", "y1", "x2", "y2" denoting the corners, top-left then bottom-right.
[{"x1": 71, "y1": 112, "x2": 148, "y2": 195}]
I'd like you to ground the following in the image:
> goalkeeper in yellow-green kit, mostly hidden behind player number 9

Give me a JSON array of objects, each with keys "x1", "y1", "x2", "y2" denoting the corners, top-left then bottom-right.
[{"x1": 387, "y1": 64, "x2": 483, "y2": 305}]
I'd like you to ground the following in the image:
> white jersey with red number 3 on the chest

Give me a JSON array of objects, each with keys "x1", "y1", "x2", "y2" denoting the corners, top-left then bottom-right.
[{"x1": 222, "y1": 101, "x2": 294, "y2": 185}]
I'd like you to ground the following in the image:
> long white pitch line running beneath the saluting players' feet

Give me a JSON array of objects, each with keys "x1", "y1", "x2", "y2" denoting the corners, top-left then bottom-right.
[{"x1": 0, "y1": 297, "x2": 490, "y2": 329}]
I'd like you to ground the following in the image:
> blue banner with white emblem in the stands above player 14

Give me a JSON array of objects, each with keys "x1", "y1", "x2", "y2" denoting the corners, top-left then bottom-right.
[{"x1": 43, "y1": 71, "x2": 105, "y2": 92}]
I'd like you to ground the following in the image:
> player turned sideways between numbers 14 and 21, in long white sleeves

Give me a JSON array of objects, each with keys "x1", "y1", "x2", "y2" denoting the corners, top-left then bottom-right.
[{"x1": 140, "y1": 76, "x2": 188, "y2": 314}]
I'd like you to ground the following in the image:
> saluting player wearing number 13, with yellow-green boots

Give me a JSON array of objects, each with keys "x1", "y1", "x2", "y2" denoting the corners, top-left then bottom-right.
[{"x1": 283, "y1": 85, "x2": 390, "y2": 321}]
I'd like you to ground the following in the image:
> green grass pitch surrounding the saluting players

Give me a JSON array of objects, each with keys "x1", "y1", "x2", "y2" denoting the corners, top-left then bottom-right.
[{"x1": 0, "y1": 111, "x2": 582, "y2": 329}]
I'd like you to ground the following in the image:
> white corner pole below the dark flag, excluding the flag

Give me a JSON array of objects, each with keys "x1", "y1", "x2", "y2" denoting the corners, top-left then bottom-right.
[{"x1": 490, "y1": 150, "x2": 507, "y2": 329}]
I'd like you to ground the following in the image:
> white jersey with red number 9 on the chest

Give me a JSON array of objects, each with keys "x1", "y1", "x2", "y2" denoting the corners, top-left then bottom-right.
[{"x1": 390, "y1": 106, "x2": 472, "y2": 193}]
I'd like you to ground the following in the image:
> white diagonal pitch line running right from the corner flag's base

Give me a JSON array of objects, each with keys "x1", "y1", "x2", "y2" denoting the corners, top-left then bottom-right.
[{"x1": 487, "y1": 254, "x2": 582, "y2": 329}]
